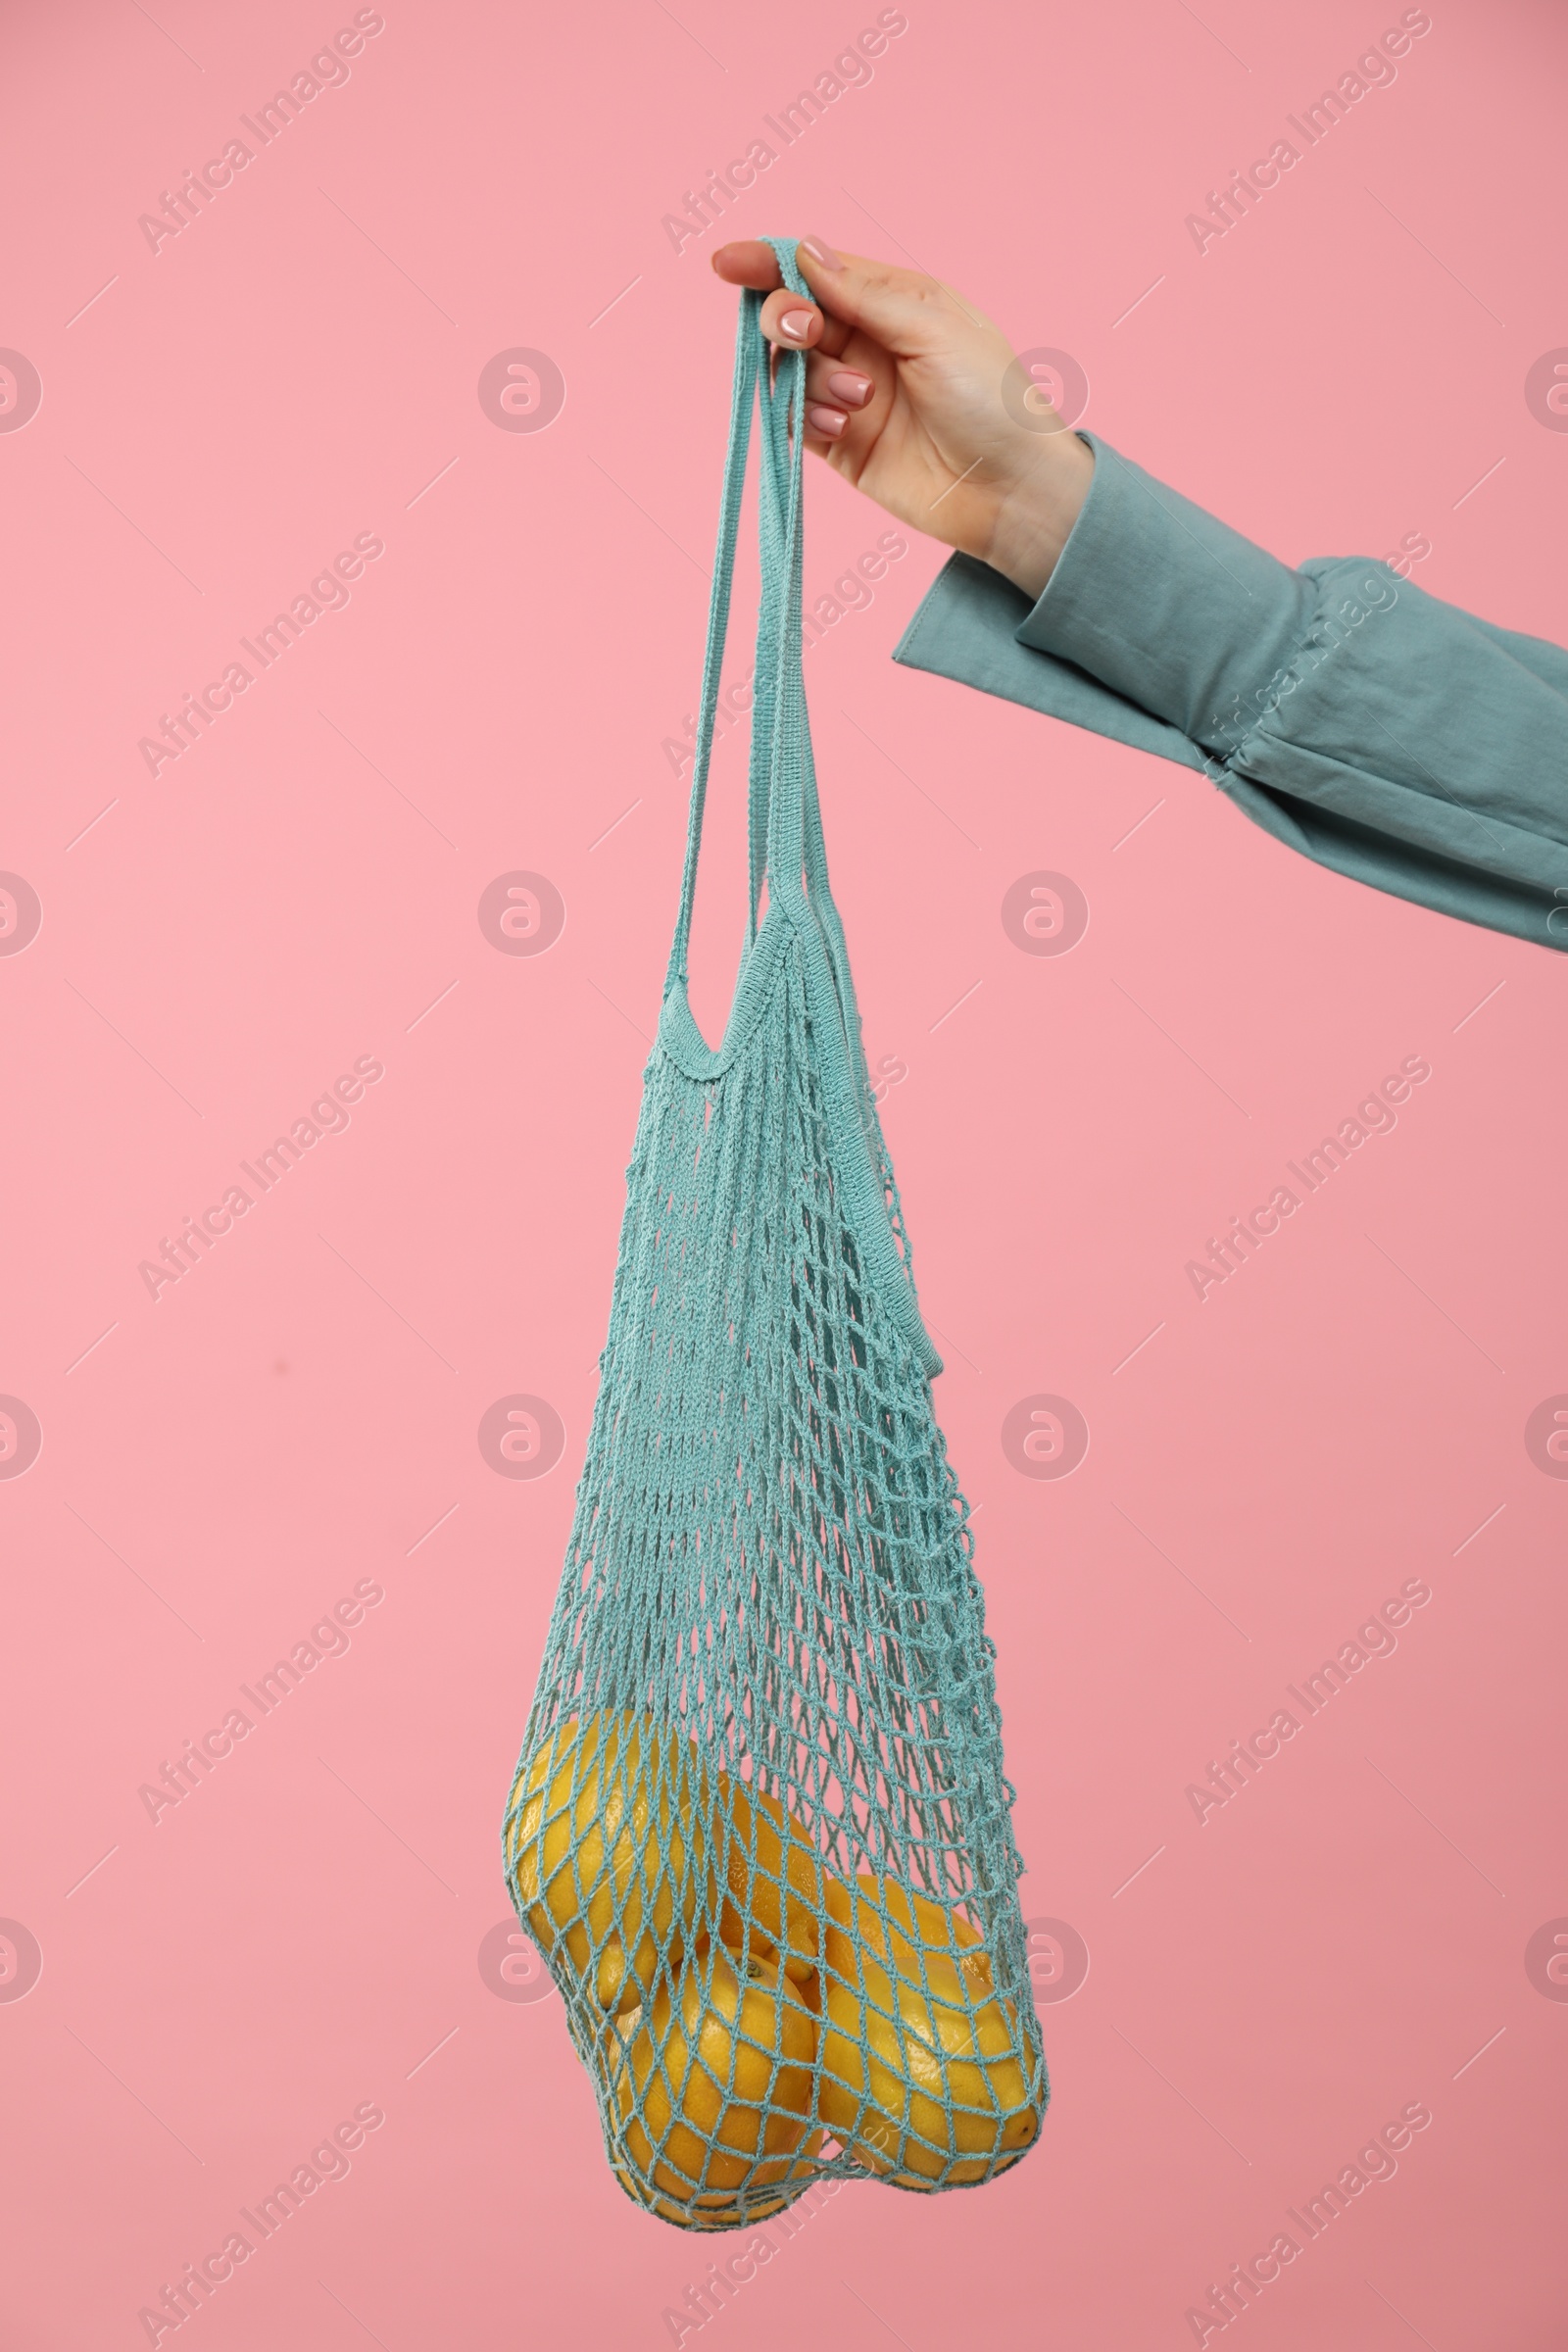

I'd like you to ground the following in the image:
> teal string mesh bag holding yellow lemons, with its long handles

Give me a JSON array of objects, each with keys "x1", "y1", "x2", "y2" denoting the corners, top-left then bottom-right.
[{"x1": 503, "y1": 240, "x2": 1049, "y2": 2230}]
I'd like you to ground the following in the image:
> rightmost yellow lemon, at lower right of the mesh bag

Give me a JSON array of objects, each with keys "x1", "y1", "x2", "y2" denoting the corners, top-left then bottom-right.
[{"x1": 818, "y1": 1952, "x2": 1042, "y2": 2187}]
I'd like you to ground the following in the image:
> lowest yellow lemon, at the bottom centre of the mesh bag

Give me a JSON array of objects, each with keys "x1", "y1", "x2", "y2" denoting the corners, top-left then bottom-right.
[{"x1": 609, "y1": 1945, "x2": 820, "y2": 2228}]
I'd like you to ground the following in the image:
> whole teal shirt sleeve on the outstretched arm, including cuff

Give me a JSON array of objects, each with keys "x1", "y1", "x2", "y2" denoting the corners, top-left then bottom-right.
[{"x1": 894, "y1": 433, "x2": 1568, "y2": 948}]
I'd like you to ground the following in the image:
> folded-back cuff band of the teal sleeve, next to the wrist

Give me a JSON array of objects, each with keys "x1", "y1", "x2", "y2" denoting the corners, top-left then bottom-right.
[{"x1": 1015, "y1": 433, "x2": 1314, "y2": 748}]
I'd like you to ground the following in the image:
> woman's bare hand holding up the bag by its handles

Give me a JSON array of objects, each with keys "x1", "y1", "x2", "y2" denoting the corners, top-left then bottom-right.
[{"x1": 712, "y1": 237, "x2": 1093, "y2": 598}]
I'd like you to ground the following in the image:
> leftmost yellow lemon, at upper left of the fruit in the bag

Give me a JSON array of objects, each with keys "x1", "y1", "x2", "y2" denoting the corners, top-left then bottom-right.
[{"x1": 506, "y1": 1712, "x2": 708, "y2": 2011}]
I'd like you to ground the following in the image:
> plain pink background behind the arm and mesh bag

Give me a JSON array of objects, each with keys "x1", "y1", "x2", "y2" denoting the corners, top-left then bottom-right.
[{"x1": 0, "y1": 0, "x2": 1568, "y2": 2352}]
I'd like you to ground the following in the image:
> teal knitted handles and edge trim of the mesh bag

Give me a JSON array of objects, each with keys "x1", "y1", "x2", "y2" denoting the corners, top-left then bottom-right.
[{"x1": 661, "y1": 237, "x2": 943, "y2": 1378}]
